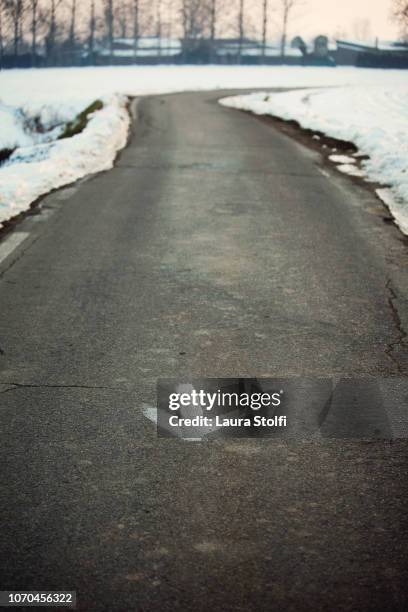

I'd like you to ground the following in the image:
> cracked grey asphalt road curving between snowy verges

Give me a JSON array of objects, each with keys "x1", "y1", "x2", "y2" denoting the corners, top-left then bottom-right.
[{"x1": 0, "y1": 93, "x2": 408, "y2": 612}]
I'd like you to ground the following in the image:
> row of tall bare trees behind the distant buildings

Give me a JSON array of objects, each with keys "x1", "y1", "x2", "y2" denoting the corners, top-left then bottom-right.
[{"x1": 0, "y1": 0, "x2": 303, "y2": 67}]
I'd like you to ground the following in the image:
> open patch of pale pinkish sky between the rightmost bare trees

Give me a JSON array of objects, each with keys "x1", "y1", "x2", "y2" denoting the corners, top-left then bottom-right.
[{"x1": 280, "y1": 0, "x2": 398, "y2": 39}]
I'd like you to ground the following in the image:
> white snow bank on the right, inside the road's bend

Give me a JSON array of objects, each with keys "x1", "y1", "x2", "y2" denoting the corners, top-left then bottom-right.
[{"x1": 221, "y1": 87, "x2": 408, "y2": 234}]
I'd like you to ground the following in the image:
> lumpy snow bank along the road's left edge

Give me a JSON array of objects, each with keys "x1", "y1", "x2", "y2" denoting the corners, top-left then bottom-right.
[{"x1": 0, "y1": 96, "x2": 130, "y2": 222}]
